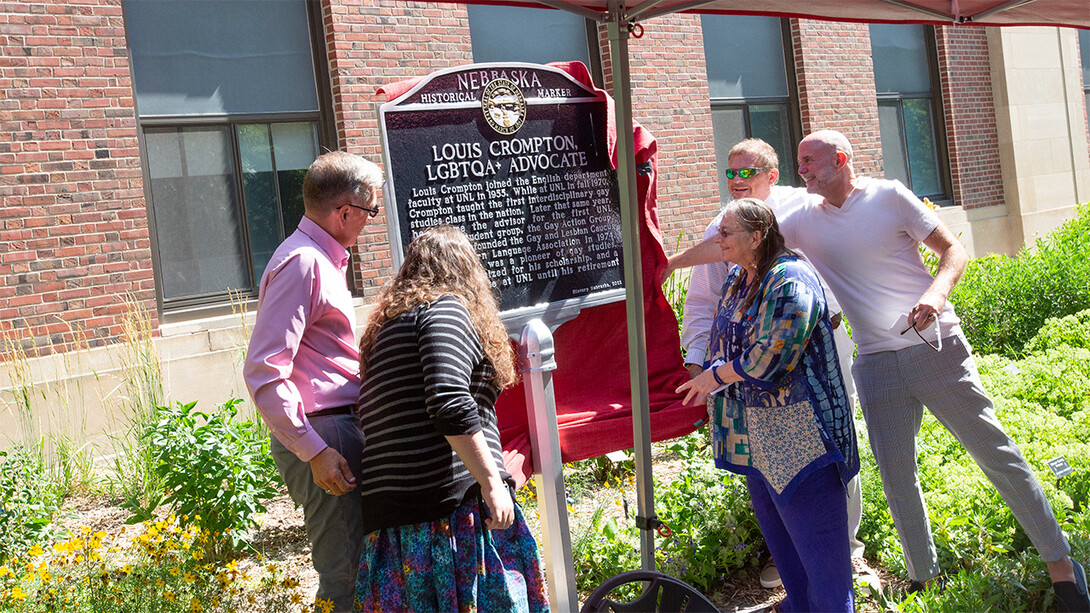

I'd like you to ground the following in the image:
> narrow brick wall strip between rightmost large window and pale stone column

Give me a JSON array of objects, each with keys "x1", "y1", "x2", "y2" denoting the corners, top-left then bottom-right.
[{"x1": 935, "y1": 26, "x2": 1003, "y2": 209}]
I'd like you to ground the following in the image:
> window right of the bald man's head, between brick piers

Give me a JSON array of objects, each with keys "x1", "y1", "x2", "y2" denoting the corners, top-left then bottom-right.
[{"x1": 870, "y1": 24, "x2": 952, "y2": 204}]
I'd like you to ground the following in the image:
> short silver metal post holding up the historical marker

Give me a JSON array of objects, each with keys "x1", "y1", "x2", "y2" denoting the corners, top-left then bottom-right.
[{"x1": 519, "y1": 320, "x2": 579, "y2": 611}]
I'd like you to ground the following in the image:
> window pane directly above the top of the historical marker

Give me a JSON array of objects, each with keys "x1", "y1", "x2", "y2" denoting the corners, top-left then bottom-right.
[{"x1": 467, "y1": 4, "x2": 602, "y2": 76}]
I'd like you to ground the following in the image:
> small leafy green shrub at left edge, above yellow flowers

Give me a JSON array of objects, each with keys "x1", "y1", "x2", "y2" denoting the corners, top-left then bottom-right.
[{"x1": 0, "y1": 444, "x2": 61, "y2": 563}]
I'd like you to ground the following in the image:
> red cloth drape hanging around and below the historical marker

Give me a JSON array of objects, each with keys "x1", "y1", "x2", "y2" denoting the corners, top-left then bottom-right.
[{"x1": 378, "y1": 62, "x2": 706, "y2": 485}]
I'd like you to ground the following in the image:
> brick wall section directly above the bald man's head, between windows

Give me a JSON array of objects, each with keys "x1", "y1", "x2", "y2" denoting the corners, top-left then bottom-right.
[{"x1": 791, "y1": 20, "x2": 885, "y2": 177}]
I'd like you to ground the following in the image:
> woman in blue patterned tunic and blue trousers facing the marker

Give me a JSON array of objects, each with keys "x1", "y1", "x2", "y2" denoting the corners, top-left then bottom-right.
[{"x1": 678, "y1": 199, "x2": 859, "y2": 612}]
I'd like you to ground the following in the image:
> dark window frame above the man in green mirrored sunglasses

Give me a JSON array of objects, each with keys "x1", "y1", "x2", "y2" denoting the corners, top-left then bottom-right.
[{"x1": 702, "y1": 17, "x2": 802, "y2": 186}]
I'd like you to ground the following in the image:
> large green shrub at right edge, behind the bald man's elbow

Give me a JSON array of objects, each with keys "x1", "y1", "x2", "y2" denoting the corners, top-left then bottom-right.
[{"x1": 949, "y1": 204, "x2": 1090, "y2": 357}]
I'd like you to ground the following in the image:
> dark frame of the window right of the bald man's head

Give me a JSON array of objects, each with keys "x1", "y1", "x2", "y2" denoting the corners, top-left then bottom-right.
[{"x1": 868, "y1": 25, "x2": 955, "y2": 206}]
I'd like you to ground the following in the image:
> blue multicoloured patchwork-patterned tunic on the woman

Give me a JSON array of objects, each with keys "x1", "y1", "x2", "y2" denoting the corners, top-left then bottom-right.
[{"x1": 705, "y1": 255, "x2": 859, "y2": 502}]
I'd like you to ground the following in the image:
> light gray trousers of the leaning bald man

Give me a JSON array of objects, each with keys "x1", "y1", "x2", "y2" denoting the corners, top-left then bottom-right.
[{"x1": 852, "y1": 335, "x2": 1070, "y2": 581}]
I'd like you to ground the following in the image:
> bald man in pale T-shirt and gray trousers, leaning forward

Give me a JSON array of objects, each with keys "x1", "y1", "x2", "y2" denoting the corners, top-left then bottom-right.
[{"x1": 779, "y1": 130, "x2": 1090, "y2": 611}]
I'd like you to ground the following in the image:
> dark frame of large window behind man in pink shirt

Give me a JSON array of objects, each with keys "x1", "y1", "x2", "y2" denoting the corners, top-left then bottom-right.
[{"x1": 122, "y1": 0, "x2": 335, "y2": 314}]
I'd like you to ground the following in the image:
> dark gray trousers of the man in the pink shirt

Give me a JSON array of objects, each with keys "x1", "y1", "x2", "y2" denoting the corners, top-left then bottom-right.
[{"x1": 270, "y1": 414, "x2": 363, "y2": 613}]
